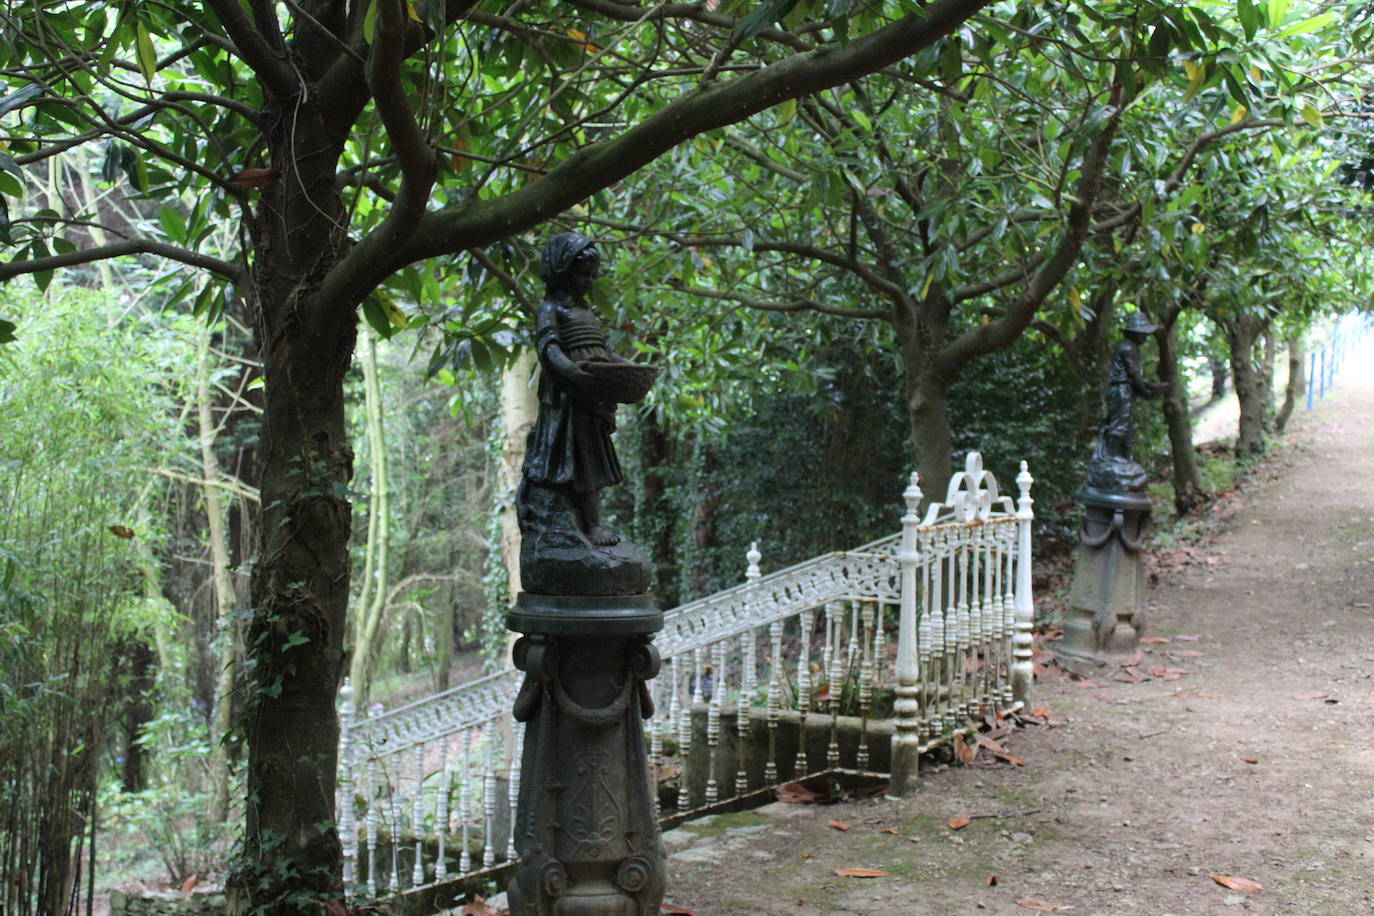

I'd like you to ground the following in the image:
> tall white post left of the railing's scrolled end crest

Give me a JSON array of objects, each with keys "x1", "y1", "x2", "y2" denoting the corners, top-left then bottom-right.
[{"x1": 890, "y1": 472, "x2": 921, "y2": 797}]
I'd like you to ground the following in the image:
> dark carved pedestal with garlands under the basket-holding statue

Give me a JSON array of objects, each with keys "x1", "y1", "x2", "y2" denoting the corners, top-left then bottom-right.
[{"x1": 507, "y1": 592, "x2": 666, "y2": 916}]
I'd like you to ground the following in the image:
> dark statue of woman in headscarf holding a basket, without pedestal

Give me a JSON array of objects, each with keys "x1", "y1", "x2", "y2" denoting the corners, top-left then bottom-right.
[{"x1": 517, "y1": 232, "x2": 657, "y2": 569}]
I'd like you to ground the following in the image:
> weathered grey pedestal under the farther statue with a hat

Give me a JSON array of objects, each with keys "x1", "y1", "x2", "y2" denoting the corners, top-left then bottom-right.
[{"x1": 1054, "y1": 486, "x2": 1150, "y2": 662}]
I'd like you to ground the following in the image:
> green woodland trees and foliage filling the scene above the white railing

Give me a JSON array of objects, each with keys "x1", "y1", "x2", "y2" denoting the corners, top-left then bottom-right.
[{"x1": 0, "y1": 0, "x2": 1374, "y2": 913}]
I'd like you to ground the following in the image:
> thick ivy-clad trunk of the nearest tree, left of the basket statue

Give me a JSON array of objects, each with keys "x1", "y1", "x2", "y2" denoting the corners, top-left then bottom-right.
[{"x1": 231, "y1": 93, "x2": 357, "y2": 916}]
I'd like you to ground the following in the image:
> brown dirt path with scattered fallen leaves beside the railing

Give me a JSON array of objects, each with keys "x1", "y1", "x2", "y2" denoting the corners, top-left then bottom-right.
[{"x1": 668, "y1": 341, "x2": 1374, "y2": 916}]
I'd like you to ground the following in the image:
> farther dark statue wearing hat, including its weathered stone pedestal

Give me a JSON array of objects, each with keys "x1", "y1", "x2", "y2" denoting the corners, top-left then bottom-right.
[{"x1": 1055, "y1": 312, "x2": 1168, "y2": 662}]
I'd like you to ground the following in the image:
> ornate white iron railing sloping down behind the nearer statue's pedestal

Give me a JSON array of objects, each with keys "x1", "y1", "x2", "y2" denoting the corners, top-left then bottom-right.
[{"x1": 338, "y1": 452, "x2": 1033, "y2": 897}]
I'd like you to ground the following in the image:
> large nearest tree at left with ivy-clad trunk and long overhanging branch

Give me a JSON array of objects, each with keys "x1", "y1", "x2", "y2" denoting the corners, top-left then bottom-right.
[{"x1": 0, "y1": 0, "x2": 987, "y2": 913}]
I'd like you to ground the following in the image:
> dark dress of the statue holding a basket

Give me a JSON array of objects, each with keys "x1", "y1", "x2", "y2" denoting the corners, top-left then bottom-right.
[{"x1": 525, "y1": 299, "x2": 624, "y2": 493}]
